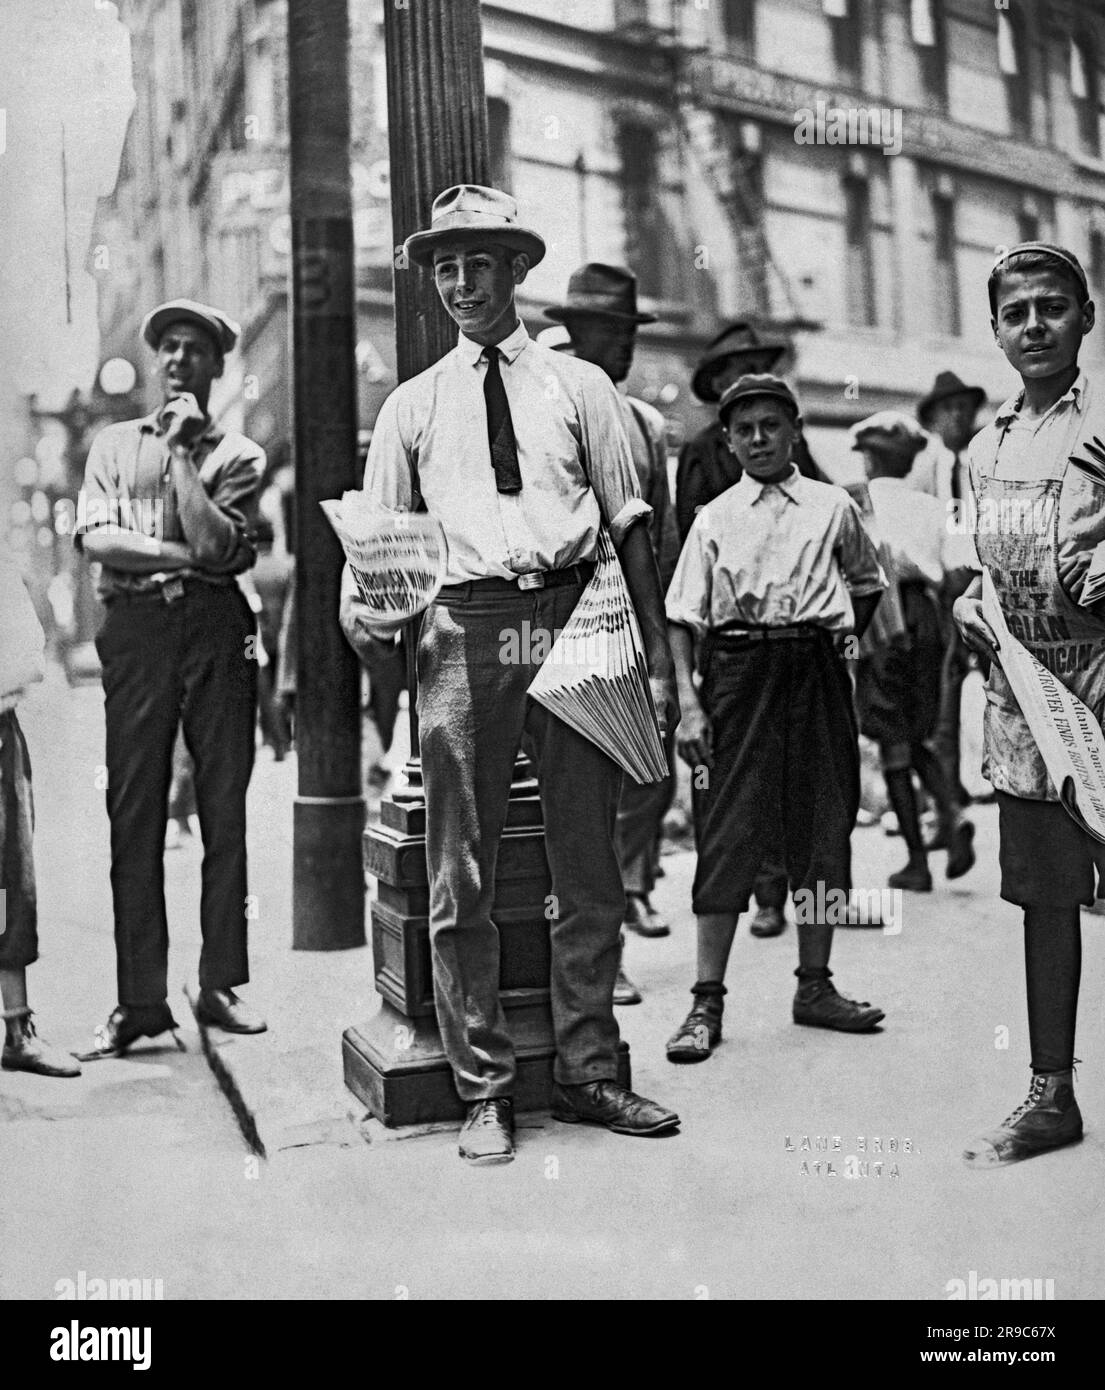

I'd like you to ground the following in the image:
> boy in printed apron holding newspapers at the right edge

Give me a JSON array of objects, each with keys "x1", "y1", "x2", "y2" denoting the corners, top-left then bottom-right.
[{"x1": 955, "y1": 242, "x2": 1105, "y2": 1169}]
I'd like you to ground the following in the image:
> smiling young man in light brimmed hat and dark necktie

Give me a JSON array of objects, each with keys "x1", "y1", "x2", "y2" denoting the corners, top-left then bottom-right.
[{"x1": 341, "y1": 185, "x2": 678, "y2": 1163}]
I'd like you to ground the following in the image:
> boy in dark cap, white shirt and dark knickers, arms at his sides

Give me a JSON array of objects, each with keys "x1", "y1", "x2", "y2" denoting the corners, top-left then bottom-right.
[{"x1": 667, "y1": 374, "x2": 887, "y2": 1062}]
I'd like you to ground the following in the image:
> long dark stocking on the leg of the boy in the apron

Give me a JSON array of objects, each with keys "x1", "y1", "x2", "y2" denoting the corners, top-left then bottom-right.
[{"x1": 1024, "y1": 908, "x2": 1081, "y2": 1074}]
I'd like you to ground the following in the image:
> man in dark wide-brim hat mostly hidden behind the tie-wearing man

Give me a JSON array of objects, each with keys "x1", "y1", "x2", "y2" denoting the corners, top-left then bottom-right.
[{"x1": 545, "y1": 261, "x2": 680, "y2": 1004}]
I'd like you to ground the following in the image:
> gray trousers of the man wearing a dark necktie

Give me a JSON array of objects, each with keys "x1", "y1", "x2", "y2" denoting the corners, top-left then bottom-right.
[{"x1": 418, "y1": 584, "x2": 625, "y2": 1102}]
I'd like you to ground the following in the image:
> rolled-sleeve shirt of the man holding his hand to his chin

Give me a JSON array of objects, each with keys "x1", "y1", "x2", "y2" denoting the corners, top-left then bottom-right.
[{"x1": 74, "y1": 411, "x2": 265, "y2": 598}]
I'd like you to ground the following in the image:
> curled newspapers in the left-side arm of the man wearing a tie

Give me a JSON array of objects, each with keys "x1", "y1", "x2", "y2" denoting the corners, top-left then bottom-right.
[{"x1": 320, "y1": 492, "x2": 449, "y2": 623}]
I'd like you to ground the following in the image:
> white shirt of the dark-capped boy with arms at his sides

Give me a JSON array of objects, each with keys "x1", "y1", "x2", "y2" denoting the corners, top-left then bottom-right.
[{"x1": 667, "y1": 468, "x2": 887, "y2": 637}]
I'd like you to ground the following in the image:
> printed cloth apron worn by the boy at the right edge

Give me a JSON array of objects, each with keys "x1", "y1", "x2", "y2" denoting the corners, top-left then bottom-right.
[{"x1": 976, "y1": 433, "x2": 1105, "y2": 801}]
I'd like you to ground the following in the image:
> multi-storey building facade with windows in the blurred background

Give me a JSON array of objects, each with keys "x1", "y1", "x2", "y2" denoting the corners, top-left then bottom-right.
[{"x1": 90, "y1": 0, "x2": 1105, "y2": 478}]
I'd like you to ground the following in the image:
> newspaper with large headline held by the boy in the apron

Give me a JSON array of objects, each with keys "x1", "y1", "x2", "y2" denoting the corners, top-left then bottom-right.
[{"x1": 983, "y1": 569, "x2": 1105, "y2": 844}]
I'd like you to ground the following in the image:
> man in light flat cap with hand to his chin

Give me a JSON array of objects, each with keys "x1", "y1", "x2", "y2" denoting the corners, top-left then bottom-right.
[{"x1": 76, "y1": 299, "x2": 264, "y2": 1059}]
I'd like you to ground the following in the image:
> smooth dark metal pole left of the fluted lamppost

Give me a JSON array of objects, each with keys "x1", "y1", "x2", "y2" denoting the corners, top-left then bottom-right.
[{"x1": 288, "y1": 0, "x2": 364, "y2": 951}]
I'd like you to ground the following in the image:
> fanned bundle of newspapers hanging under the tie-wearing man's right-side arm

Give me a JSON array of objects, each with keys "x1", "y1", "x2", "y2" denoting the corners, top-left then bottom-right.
[{"x1": 530, "y1": 530, "x2": 669, "y2": 784}]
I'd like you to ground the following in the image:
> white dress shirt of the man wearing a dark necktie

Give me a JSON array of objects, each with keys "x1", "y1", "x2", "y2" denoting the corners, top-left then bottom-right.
[{"x1": 364, "y1": 322, "x2": 650, "y2": 584}]
